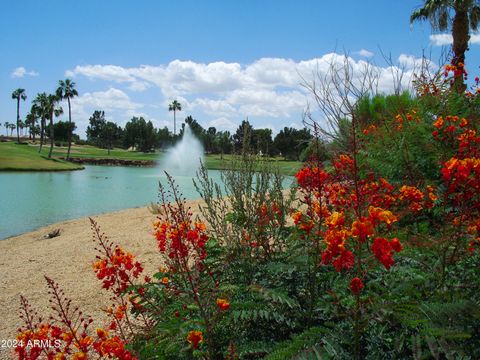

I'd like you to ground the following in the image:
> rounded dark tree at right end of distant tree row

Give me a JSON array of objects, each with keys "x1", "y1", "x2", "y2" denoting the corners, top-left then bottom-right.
[{"x1": 273, "y1": 127, "x2": 312, "y2": 160}]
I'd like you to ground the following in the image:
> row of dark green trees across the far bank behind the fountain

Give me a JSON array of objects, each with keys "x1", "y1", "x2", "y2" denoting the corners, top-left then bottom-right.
[{"x1": 86, "y1": 110, "x2": 314, "y2": 160}]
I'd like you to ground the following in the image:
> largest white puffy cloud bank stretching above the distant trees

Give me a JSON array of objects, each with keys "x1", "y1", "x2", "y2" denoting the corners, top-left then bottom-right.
[{"x1": 65, "y1": 54, "x2": 434, "y2": 135}]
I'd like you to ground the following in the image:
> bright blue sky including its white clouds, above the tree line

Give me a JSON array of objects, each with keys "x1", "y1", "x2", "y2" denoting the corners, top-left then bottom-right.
[{"x1": 0, "y1": 0, "x2": 480, "y2": 137}]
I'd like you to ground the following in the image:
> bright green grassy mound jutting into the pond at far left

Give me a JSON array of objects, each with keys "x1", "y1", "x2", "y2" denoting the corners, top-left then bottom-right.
[{"x1": 0, "y1": 142, "x2": 83, "y2": 171}]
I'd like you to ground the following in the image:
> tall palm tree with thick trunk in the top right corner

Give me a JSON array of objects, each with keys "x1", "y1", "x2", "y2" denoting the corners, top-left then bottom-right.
[{"x1": 410, "y1": 0, "x2": 480, "y2": 92}]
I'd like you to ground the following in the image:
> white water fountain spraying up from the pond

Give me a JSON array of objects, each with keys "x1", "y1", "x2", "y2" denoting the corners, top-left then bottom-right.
[{"x1": 160, "y1": 124, "x2": 203, "y2": 178}]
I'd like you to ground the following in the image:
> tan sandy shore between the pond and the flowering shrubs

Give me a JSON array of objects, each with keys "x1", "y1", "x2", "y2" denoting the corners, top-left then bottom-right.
[{"x1": 0, "y1": 200, "x2": 200, "y2": 359}]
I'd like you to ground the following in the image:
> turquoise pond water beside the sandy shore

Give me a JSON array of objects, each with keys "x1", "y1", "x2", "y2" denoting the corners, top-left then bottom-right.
[{"x1": 0, "y1": 166, "x2": 225, "y2": 239}]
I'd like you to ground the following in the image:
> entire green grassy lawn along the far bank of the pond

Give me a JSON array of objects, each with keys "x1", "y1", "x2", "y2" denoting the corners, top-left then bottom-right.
[{"x1": 0, "y1": 141, "x2": 301, "y2": 175}]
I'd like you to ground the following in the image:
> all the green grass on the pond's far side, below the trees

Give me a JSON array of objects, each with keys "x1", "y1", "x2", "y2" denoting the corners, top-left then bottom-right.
[{"x1": 0, "y1": 141, "x2": 302, "y2": 175}]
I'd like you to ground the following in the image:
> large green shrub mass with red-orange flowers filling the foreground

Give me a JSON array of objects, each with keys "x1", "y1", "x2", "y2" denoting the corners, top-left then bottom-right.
[{"x1": 16, "y1": 59, "x2": 480, "y2": 360}]
